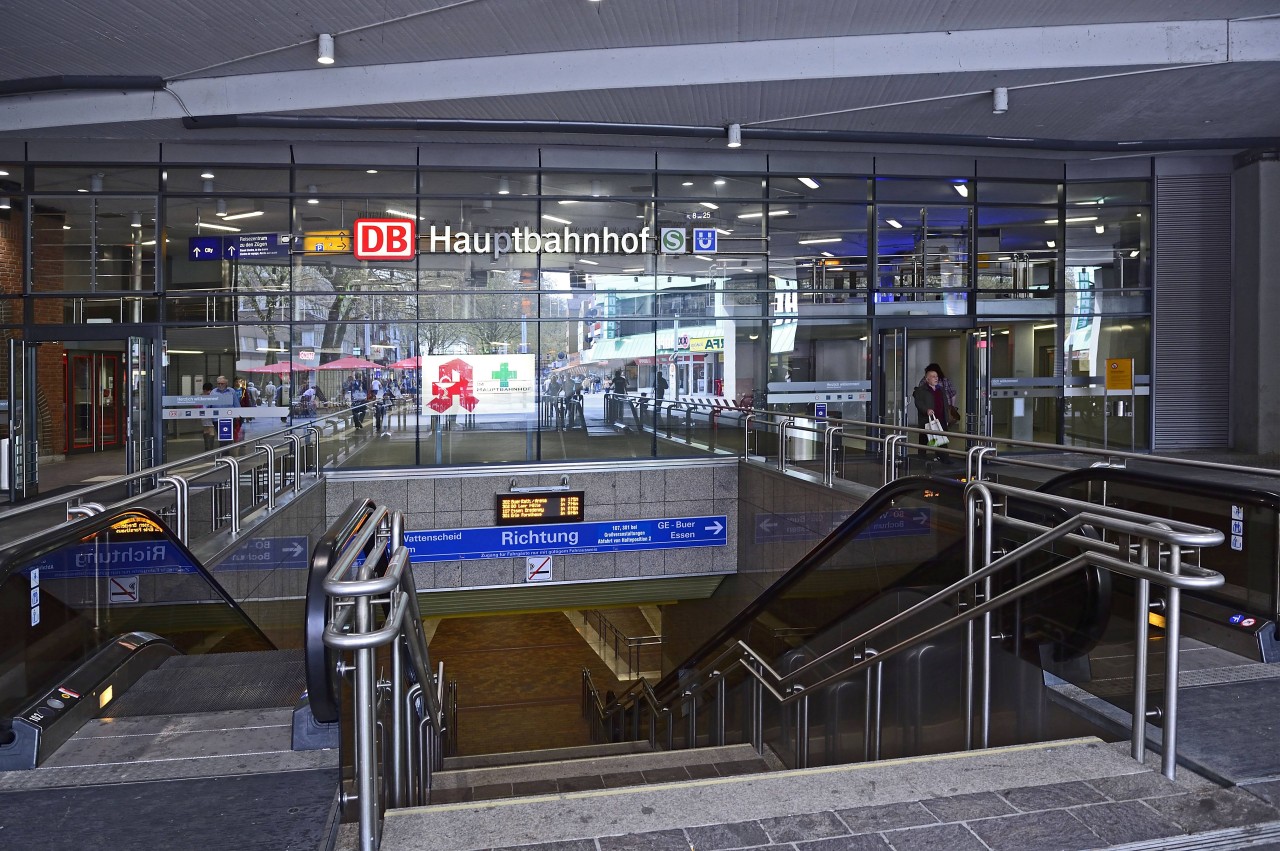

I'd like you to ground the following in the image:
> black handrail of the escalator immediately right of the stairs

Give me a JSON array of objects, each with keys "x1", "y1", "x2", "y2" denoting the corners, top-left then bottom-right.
[{"x1": 653, "y1": 476, "x2": 964, "y2": 695}]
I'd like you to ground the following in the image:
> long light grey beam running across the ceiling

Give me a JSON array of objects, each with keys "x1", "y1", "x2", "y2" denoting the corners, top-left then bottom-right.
[{"x1": 0, "y1": 19, "x2": 1280, "y2": 131}]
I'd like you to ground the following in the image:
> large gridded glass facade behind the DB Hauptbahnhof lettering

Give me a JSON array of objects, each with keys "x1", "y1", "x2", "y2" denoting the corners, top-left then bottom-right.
[{"x1": 0, "y1": 148, "x2": 1152, "y2": 478}]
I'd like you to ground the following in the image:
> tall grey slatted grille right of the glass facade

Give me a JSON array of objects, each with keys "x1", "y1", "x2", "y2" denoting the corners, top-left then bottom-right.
[{"x1": 1152, "y1": 174, "x2": 1231, "y2": 450}]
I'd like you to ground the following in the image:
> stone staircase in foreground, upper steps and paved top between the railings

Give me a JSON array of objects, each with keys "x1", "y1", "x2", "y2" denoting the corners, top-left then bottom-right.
[{"x1": 353, "y1": 737, "x2": 1280, "y2": 851}]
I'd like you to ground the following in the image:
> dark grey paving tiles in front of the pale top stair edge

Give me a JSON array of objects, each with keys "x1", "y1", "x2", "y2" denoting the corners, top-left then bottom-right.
[{"x1": 483, "y1": 773, "x2": 1280, "y2": 851}]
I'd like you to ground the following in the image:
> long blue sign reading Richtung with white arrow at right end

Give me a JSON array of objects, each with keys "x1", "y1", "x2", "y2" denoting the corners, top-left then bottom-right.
[{"x1": 404, "y1": 514, "x2": 728, "y2": 562}]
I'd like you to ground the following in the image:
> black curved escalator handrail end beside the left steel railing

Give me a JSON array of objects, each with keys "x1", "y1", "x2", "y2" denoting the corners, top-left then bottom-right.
[{"x1": 303, "y1": 499, "x2": 378, "y2": 724}]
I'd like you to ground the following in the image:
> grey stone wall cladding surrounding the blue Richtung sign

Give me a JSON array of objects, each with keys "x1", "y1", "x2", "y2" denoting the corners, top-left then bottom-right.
[{"x1": 328, "y1": 463, "x2": 740, "y2": 587}]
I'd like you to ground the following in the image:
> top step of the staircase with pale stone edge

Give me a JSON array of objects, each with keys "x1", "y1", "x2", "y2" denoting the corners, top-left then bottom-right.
[{"x1": 373, "y1": 737, "x2": 1233, "y2": 851}]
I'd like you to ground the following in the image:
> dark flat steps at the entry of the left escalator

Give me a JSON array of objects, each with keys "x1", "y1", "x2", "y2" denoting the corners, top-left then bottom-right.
[{"x1": 104, "y1": 651, "x2": 306, "y2": 718}]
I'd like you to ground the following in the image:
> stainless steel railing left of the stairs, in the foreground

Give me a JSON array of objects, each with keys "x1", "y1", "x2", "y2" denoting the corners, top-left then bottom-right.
[{"x1": 324, "y1": 505, "x2": 456, "y2": 851}]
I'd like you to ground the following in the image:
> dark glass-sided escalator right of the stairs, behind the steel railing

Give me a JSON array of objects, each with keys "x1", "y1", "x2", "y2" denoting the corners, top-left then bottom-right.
[{"x1": 605, "y1": 477, "x2": 1114, "y2": 767}]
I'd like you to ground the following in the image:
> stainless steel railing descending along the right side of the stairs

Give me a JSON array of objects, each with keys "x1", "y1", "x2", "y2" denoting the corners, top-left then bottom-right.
[{"x1": 586, "y1": 481, "x2": 1224, "y2": 779}]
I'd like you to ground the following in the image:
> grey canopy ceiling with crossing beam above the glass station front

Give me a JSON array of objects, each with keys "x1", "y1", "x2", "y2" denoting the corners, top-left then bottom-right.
[{"x1": 0, "y1": 0, "x2": 1280, "y2": 151}]
